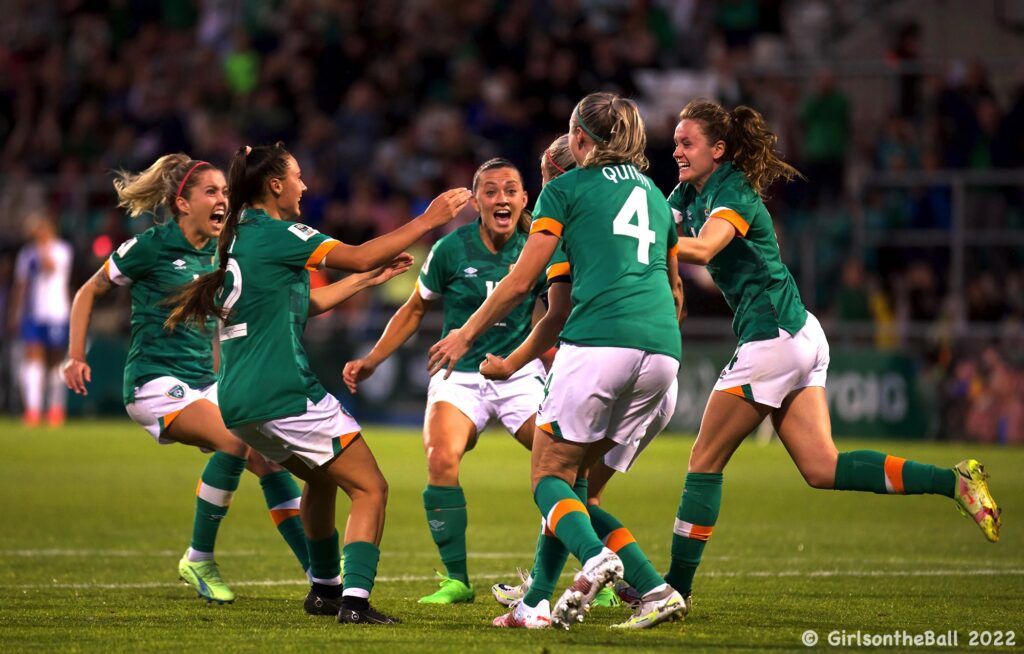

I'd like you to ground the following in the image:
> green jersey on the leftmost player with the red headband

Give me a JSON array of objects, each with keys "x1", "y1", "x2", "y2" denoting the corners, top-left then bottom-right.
[{"x1": 103, "y1": 220, "x2": 217, "y2": 404}]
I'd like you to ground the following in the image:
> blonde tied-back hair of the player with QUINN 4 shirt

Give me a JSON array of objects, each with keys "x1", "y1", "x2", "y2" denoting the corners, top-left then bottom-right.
[{"x1": 571, "y1": 93, "x2": 648, "y2": 171}]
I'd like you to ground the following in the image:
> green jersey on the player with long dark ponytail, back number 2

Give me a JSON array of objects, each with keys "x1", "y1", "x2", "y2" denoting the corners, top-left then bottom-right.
[{"x1": 217, "y1": 209, "x2": 338, "y2": 427}]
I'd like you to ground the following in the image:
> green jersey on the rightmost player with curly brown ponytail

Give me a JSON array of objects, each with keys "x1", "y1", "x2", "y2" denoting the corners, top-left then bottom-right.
[{"x1": 669, "y1": 162, "x2": 807, "y2": 345}]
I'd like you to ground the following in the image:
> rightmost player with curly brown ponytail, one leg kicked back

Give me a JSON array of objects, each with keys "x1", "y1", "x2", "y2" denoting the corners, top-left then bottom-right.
[{"x1": 666, "y1": 100, "x2": 999, "y2": 609}]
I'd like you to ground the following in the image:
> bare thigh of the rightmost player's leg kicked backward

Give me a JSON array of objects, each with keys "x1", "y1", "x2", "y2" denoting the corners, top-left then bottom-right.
[{"x1": 771, "y1": 386, "x2": 839, "y2": 488}]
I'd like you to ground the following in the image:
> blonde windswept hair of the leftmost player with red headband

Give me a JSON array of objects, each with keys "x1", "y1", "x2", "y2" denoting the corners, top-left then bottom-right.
[{"x1": 114, "y1": 152, "x2": 216, "y2": 218}]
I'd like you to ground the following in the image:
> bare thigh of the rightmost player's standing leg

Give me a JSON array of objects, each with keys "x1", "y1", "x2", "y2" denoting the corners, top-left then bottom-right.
[{"x1": 689, "y1": 391, "x2": 771, "y2": 473}]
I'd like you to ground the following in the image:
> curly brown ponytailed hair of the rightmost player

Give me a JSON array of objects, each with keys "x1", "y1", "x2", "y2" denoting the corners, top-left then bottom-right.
[{"x1": 679, "y1": 99, "x2": 804, "y2": 195}]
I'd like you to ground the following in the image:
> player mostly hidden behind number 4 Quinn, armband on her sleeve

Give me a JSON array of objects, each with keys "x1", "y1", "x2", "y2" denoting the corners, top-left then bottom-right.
[{"x1": 489, "y1": 134, "x2": 685, "y2": 628}]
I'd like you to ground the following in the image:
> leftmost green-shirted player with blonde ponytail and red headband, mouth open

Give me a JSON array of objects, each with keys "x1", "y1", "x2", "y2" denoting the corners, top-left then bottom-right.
[{"x1": 63, "y1": 155, "x2": 309, "y2": 603}]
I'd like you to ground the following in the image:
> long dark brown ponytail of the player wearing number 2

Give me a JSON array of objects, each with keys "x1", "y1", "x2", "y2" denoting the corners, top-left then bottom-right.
[{"x1": 163, "y1": 141, "x2": 290, "y2": 331}]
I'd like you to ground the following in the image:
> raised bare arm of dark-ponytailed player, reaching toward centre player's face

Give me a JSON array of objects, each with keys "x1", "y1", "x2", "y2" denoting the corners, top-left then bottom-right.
[{"x1": 324, "y1": 188, "x2": 471, "y2": 272}]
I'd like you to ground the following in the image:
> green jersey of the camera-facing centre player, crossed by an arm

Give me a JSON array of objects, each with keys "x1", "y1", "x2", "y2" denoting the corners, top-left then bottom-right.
[{"x1": 417, "y1": 220, "x2": 545, "y2": 373}]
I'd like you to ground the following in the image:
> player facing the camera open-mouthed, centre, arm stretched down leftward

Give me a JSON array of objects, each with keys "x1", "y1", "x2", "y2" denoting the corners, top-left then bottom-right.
[{"x1": 344, "y1": 159, "x2": 546, "y2": 604}]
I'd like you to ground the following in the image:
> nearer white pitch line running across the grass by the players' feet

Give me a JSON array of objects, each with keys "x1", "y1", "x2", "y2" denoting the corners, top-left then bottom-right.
[{"x1": 0, "y1": 568, "x2": 1024, "y2": 591}]
